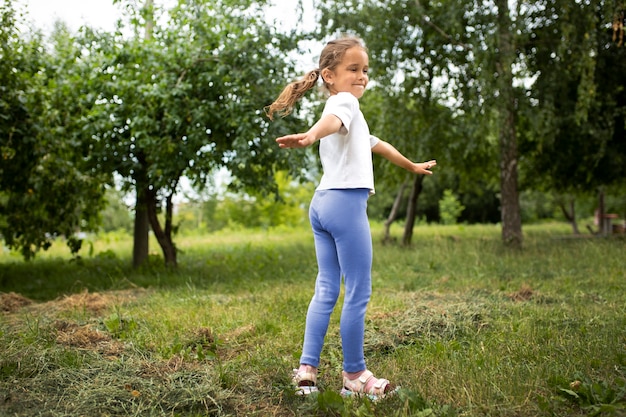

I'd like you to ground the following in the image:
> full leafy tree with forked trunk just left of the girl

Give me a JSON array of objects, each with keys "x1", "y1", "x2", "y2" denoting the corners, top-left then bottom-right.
[{"x1": 84, "y1": 0, "x2": 304, "y2": 266}]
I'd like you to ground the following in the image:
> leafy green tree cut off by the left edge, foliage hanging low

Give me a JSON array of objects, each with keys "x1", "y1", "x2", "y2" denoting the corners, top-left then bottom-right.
[{"x1": 0, "y1": 1, "x2": 108, "y2": 259}]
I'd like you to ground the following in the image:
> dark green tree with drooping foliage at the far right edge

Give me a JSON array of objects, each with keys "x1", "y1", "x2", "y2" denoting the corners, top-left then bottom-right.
[{"x1": 521, "y1": 0, "x2": 626, "y2": 233}]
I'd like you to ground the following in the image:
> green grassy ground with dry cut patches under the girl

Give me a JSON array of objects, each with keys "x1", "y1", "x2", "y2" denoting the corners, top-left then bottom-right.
[{"x1": 0, "y1": 219, "x2": 626, "y2": 416}]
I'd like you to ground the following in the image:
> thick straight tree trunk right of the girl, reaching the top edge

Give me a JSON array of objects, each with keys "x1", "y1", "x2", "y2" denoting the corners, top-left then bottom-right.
[{"x1": 496, "y1": 0, "x2": 523, "y2": 247}]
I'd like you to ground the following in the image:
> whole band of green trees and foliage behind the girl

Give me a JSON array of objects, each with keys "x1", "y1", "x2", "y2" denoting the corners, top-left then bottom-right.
[{"x1": 0, "y1": 0, "x2": 626, "y2": 265}]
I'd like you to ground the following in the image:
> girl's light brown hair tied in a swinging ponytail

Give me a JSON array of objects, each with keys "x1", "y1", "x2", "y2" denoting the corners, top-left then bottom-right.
[{"x1": 265, "y1": 36, "x2": 365, "y2": 120}]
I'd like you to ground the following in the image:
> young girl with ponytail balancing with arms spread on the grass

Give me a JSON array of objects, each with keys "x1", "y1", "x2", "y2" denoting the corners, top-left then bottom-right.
[{"x1": 266, "y1": 37, "x2": 437, "y2": 399}]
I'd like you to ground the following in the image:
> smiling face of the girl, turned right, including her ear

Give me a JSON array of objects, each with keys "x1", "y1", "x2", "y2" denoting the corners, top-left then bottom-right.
[{"x1": 322, "y1": 46, "x2": 369, "y2": 98}]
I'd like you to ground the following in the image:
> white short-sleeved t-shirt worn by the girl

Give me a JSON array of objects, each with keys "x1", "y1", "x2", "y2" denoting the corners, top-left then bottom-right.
[{"x1": 317, "y1": 92, "x2": 380, "y2": 194}]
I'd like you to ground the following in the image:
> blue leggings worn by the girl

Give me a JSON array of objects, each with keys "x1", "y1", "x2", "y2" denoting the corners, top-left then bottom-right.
[{"x1": 300, "y1": 188, "x2": 372, "y2": 372}]
